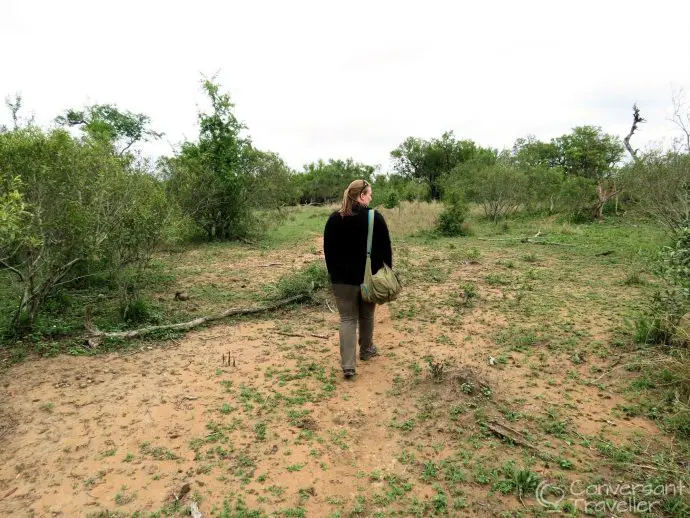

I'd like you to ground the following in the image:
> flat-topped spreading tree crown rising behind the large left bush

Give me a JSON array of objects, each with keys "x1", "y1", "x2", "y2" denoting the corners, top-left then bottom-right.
[{"x1": 55, "y1": 104, "x2": 163, "y2": 155}]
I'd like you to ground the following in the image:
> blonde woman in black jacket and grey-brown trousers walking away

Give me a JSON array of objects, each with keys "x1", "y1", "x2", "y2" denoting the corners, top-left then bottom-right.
[{"x1": 323, "y1": 180, "x2": 393, "y2": 379}]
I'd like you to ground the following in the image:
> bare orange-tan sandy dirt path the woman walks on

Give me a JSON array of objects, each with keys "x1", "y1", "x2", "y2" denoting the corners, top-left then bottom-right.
[{"x1": 0, "y1": 292, "x2": 653, "y2": 516}]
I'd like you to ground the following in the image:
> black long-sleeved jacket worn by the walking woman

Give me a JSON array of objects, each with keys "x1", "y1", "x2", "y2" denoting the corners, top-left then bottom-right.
[{"x1": 323, "y1": 207, "x2": 393, "y2": 286}]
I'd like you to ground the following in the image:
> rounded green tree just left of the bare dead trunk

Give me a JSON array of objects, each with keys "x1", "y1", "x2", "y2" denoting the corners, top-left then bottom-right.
[{"x1": 553, "y1": 126, "x2": 623, "y2": 217}]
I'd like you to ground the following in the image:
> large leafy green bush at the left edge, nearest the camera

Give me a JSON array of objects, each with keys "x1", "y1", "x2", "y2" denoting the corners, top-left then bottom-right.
[{"x1": 0, "y1": 127, "x2": 167, "y2": 328}]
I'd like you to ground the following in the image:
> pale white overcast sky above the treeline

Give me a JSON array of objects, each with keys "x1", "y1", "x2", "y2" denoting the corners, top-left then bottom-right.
[{"x1": 0, "y1": 0, "x2": 690, "y2": 171}]
